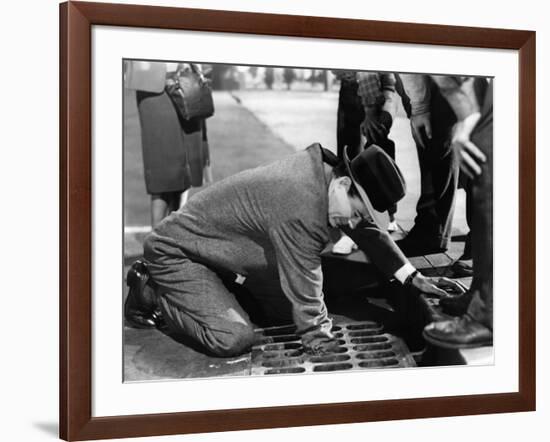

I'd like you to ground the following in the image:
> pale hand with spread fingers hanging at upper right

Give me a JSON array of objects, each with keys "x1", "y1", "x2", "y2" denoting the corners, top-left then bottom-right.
[{"x1": 452, "y1": 112, "x2": 487, "y2": 179}]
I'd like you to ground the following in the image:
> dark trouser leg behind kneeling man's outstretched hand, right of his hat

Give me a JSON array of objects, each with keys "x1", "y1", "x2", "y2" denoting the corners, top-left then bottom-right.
[{"x1": 415, "y1": 85, "x2": 458, "y2": 247}]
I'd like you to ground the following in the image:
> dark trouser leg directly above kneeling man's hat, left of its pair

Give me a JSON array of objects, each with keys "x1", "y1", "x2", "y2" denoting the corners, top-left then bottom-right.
[{"x1": 336, "y1": 81, "x2": 365, "y2": 159}]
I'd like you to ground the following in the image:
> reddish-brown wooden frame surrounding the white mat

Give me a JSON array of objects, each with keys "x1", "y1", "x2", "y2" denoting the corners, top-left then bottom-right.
[{"x1": 59, "y1": 2, "x2": 536, "y2": 440}]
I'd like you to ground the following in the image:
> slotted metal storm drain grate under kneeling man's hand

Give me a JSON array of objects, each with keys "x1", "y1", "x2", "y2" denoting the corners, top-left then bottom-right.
[{"x1": 251, "y1": 322, "x2": 416, "y2": 375}]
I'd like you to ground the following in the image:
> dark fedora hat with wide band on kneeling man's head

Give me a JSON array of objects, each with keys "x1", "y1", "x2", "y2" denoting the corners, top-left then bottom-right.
[{"x1": 344, "y1": 144, "x2": 406, "y2": 228}]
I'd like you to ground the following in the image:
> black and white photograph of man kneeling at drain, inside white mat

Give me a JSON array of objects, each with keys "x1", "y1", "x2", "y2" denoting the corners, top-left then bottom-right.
[{"x1": 122, "y1": 59, "x2": 495, "y2": 382}]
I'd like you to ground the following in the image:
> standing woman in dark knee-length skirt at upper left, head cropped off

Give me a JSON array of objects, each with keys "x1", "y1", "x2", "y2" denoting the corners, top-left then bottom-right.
[{"x1": 125, "y1": 61, "x2": 210, "y2": 227}]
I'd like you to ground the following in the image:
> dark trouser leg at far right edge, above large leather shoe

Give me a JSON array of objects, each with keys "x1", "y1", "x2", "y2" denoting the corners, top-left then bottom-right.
[{"x1": 468, "y1": 85, "x2": 493, "y2": 329}]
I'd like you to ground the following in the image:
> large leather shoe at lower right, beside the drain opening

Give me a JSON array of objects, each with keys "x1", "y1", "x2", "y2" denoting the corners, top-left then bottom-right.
[{"x1": 423, "y1": 315, "x2": 493, "y2": 349}]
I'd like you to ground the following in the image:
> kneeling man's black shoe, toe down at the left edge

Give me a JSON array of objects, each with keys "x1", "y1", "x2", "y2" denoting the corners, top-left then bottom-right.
[{"x1": 124, "y1": 261, "x2": 161, "y2": 328}]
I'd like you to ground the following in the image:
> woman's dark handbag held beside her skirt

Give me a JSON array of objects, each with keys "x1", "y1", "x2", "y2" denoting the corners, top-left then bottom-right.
[{"x1": 165, "y1": 65, "x2": 214, "y2": 120}]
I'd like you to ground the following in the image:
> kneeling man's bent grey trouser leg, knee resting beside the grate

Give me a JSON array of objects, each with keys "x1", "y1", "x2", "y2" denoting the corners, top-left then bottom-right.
[{"x1": 145, "y1": 234, "x2": 254, "y2": 357}]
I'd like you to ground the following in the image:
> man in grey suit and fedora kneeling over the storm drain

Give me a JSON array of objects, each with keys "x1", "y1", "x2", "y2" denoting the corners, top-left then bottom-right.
[{"x1": 125, "y1": 144, "x2": 460, "y2": 356}]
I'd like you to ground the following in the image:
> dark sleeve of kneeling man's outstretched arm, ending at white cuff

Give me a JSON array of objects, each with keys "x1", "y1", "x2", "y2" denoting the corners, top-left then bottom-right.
[{"x1": 342, "y1": 221, "x2": 409, "y2": 278}]
